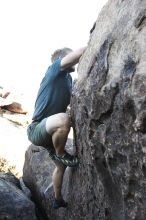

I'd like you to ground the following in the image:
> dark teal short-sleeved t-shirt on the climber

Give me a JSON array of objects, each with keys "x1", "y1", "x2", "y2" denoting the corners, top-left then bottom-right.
[{"x1": 32, "y1": 59, "x2": 72, "y2": 121}]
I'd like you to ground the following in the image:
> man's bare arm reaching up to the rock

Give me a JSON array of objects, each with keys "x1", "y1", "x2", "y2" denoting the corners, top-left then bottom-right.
[{"x1": 61, "y1": 47, "x2": 86, "y2": 70}]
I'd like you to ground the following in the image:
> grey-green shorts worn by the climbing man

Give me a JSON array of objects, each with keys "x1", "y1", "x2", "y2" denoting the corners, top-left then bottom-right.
[{"x1": 27, "y1": 118, "x2": 54, "y2": 150}]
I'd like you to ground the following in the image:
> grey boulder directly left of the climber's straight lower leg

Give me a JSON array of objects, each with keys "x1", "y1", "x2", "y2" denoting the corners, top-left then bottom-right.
[{"x1": 23, "y1": 144, "x2": 55, "y2": 219}]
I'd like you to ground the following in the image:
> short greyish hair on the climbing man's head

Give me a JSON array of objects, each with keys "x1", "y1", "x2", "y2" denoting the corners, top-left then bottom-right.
[{"x1": 51, "y1": 47, "x2": 72, "y2": 63}]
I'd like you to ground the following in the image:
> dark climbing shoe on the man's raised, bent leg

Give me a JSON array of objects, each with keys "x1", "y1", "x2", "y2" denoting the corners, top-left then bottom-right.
[{"x1": 55, "y1": 152, "x2": 79, "y2": 167}]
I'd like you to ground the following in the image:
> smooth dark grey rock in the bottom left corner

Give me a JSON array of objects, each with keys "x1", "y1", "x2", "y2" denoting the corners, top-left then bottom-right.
[{"x1": 0, "y1": 173, "x2": 37, "y2": 220}]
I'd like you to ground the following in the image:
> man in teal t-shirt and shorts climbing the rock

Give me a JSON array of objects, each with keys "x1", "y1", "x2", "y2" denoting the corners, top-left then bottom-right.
[{"x1": 27, "y1": 47, "x2": 85, "y2": 209}]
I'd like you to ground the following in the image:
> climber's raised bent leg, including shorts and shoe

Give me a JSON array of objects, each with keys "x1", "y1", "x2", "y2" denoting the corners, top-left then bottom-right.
[{"x1": 27, "y1": 113, "x2": 79, "y2": 167}]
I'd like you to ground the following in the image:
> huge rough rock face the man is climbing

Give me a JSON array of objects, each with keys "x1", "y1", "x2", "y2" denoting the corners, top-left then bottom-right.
[{"x1": 69, "y1": 0, "x2": 146, "y2": 220}]
